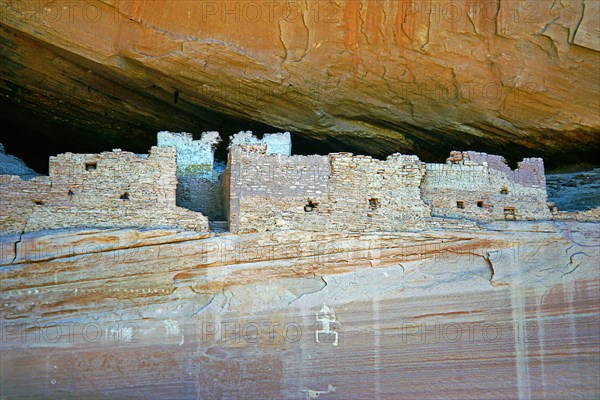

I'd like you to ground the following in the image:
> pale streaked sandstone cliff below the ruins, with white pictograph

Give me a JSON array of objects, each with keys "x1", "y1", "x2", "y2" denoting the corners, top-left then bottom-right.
[{"x1": 0, "y1": 222, "x2": 600, "y2": 399}]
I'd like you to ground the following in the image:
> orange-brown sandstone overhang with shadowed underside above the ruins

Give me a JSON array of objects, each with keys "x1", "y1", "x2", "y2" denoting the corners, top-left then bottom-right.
[{"x1": 0, "y1": 0, "x2": 600, "y2": 170}]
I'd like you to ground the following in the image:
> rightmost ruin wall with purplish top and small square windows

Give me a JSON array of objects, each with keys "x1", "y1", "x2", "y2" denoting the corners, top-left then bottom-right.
[{"x1": 423, "y1": 152, "x2": 552, "y2": 221}]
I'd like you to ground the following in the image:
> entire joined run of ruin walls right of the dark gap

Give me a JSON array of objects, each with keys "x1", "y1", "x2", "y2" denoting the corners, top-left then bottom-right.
[{"x1": 223, "y1": 144, "x2": 552, "y2": 232}]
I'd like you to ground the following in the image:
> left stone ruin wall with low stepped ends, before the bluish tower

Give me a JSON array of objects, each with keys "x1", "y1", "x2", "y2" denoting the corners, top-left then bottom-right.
[{"x1": 0, "y1": 147, "x2": 208, "y2": 234}]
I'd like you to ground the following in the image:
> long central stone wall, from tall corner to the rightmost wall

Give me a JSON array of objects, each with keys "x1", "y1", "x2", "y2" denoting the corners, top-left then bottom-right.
[{"x1": 226, "y1": 144, "x2": 430, "y2": 232}]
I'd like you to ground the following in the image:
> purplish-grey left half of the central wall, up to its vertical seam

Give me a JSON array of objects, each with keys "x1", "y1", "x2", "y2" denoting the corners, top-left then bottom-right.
[{"x1": 224, "y1": 144, "x2": 329, "y2": 232}]
